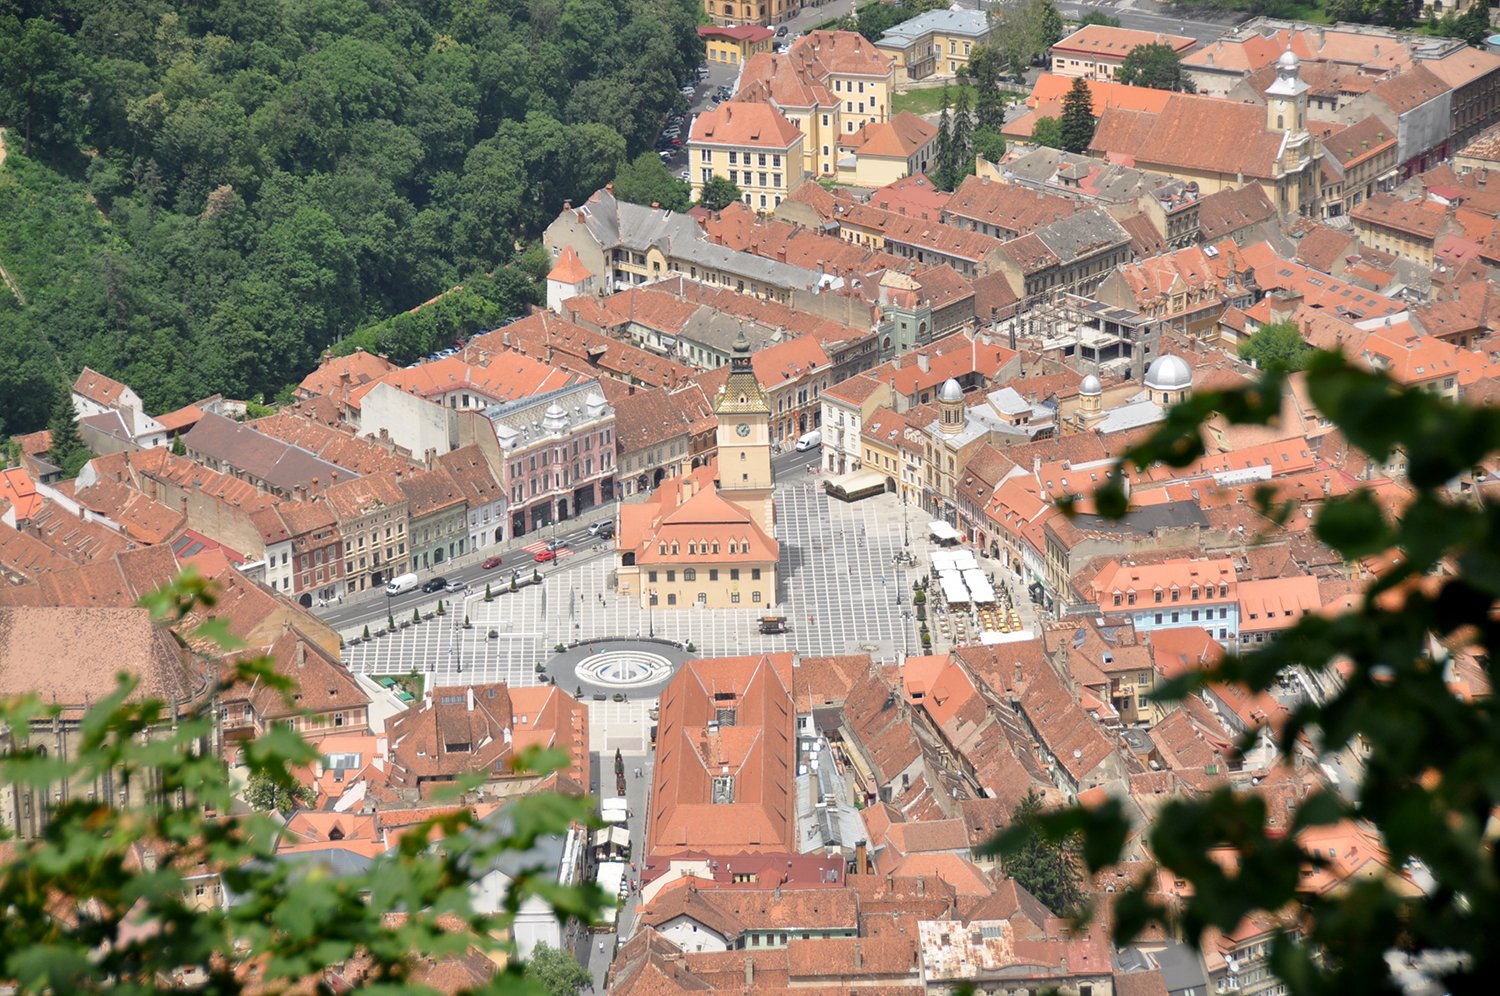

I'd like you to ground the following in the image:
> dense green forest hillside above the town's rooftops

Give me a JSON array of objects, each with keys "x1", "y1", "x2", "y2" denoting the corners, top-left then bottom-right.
[{"x1": 0, "y1": 0, "x2": 702, "y2": 434}]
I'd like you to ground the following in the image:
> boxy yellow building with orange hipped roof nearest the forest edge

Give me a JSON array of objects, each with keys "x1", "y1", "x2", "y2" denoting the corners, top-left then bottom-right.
[{"x1": 687, "y1": 101, "x2": 807, "y2": 215}]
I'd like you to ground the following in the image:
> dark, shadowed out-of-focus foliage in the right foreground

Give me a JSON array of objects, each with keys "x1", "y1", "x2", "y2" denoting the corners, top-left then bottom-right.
[{"x1": 1001, "y1": 353, "x2": 1500, "y2": 993}]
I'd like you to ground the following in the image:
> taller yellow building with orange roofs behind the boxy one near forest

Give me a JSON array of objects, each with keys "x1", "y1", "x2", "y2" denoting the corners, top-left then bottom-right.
[{"x1": 735, "y1": 32, "x2": 896, "y2": 177}]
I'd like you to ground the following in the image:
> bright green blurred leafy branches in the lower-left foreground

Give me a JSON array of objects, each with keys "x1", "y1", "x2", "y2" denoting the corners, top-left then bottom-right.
[{"x1": 0, "y1": 573, "x2": 603, "y2": 993}]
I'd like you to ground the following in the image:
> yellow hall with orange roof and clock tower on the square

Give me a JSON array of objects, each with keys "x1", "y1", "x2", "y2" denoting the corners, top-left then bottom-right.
[{"x1": 617, "y1": 333, "x2": 780, "y2": 609}]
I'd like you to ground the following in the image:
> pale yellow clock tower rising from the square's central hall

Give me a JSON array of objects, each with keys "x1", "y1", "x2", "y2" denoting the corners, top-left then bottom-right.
[{"x1": 714, "y1": 330, "x2": 776, "y2": 537}]
